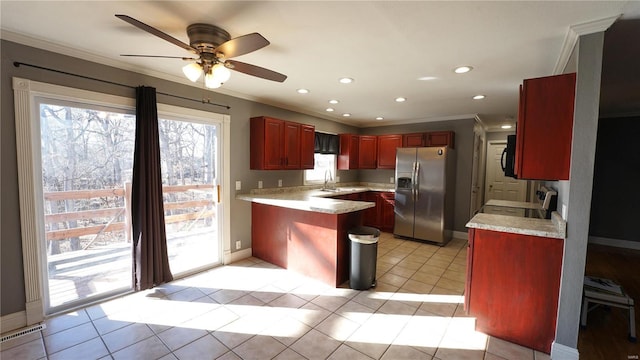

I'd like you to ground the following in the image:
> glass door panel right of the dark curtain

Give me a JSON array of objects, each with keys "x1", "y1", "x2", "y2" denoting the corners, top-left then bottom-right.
[{"x1": 159, "y1": 119, "x2": 221, "y2": 276}]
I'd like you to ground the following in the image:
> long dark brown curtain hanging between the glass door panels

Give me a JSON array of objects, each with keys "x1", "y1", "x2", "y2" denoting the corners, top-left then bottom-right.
[{"x1": 131, "y1": 86, "x2": 173, "y2": 290}]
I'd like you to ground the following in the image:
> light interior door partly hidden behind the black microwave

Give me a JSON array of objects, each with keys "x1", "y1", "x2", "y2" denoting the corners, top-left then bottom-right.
[{"x1": 484, "y1": 141, "x2": 527, "y2": 216}]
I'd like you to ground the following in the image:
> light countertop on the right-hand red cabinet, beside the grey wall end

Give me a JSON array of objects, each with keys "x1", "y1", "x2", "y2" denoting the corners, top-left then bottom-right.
[{"x1": 467, "y1": 211, "x2": 567, "y2": 239}]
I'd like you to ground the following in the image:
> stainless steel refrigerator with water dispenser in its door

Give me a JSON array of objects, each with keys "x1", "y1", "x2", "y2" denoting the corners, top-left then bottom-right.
[{"x1": 393, "y1": 147, "x2": 456, "y2": 245}]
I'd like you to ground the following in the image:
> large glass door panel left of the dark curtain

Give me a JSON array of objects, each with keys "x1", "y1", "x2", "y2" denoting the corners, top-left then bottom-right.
[{"x1": 38, "y1": 99, "x2": 135, "y2": 313}]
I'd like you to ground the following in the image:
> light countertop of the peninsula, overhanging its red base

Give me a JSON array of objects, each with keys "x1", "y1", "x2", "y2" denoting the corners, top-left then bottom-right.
[{"x1": 236, "y1": 186, "x2": 394, "y2": 215}]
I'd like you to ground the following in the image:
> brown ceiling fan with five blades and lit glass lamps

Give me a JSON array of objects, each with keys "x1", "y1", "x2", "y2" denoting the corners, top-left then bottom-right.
[{"x1": 116, "y1": 15, "x2": 287, "y2": 89}]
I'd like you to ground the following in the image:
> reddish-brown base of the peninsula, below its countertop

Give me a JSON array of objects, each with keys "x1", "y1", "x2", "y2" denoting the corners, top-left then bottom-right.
[{"x1": 251, "y1": 203, "x2": 362, "y2": 286}]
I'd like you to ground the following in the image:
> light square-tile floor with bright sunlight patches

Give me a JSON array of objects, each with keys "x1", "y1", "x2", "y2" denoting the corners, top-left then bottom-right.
[{"x1": 0, "y1": 233, "x2": 549, "y2": 360}]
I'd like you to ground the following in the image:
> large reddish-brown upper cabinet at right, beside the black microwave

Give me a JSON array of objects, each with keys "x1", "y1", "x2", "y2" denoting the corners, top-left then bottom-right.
[{"x1": 515, "y1": 73, "x2": 576, "y2": 180}]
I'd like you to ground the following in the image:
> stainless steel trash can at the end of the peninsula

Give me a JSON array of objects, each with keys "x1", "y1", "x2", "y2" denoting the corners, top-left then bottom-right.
[{"x1": 349, "y1": 226, "x2": 380, "y2": 290}]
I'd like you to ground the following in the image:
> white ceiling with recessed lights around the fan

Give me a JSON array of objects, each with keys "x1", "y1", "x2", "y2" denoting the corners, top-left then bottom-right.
[{"x1": 0, "y1": 0, "x2": 640, "y2": 127}]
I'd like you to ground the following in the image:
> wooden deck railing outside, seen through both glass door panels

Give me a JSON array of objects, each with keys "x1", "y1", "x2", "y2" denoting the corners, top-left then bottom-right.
[{"x1": 44, "y1": 183, "x2": 215, "y2": 245}]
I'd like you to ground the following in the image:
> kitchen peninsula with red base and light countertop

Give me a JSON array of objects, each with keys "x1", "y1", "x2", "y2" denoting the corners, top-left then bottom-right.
[{"x1": 236, "y1": 186, "x2": 390, "y2": 286}]
